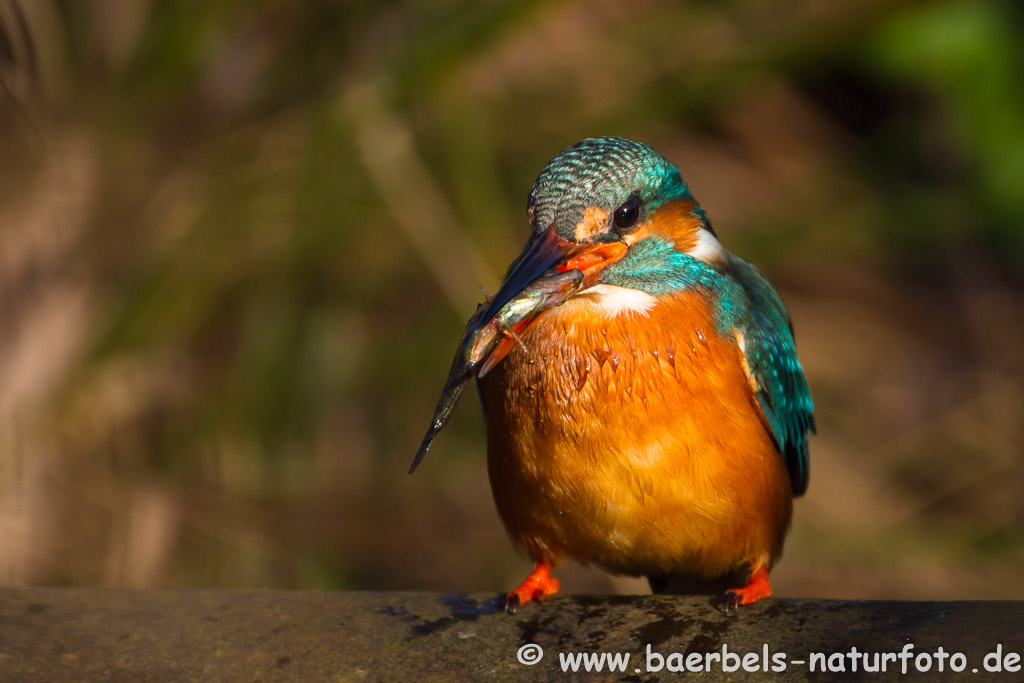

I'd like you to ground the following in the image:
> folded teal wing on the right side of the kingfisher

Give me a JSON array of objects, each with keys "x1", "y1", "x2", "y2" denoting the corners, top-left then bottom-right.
[{"x1": 730, "y1": 256, "x2": 816, "y2": 496}]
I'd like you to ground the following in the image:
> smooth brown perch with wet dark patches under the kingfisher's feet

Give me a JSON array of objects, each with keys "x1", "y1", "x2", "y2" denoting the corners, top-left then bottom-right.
[{"x1": 0, "y1": 589, "x2": 1024, "y2": 683}]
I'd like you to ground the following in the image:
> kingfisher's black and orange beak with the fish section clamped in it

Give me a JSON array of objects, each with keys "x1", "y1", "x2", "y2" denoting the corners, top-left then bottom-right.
[{"x1": 468, "y1": 225, "x2": 628, "y2": 377}]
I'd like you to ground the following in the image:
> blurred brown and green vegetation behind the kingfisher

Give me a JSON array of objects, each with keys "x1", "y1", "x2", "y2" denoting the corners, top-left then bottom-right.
[{"x1": 0, "y1": 0, "x2": 1024, "y2": 599}]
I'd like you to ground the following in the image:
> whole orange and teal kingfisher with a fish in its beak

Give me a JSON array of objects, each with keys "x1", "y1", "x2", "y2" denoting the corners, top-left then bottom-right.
[{"x1": 410, "y1": 137, "x2": 815, "y2": 612}]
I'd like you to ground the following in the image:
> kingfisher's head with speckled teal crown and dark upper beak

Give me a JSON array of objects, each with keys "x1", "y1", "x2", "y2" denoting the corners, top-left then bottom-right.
[{"x1": 471, "y1": 137, "x2": 724, "y2": 342}]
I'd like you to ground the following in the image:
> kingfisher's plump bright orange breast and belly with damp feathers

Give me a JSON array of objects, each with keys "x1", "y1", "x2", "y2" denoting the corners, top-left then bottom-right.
[{"x1": 481, "y1": 292, "x2": 792, "y2": 578}]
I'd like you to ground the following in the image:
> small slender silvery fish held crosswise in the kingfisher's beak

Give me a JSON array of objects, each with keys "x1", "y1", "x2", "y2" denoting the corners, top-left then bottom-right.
[{"x1": 409, "y1": 268, "x2": 584, "y2": 474}]
